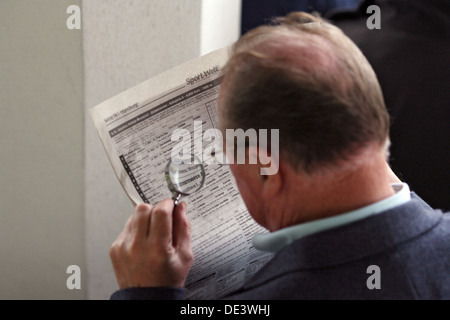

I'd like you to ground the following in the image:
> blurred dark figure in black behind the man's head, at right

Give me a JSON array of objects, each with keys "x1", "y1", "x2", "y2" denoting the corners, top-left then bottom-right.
[{"x1": 327, "y1": 0, "x2": 450, "y2": 210}]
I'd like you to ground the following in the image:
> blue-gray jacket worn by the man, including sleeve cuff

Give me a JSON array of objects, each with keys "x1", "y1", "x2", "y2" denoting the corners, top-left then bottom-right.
[{"x1": 111, "y1": 193, "x2": 450, "y2": 299}]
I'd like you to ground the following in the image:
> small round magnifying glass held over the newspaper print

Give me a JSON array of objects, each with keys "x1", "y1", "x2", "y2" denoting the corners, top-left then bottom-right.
[{"x1": 165, "y1": 155, "x2": 205, "y2": 206}]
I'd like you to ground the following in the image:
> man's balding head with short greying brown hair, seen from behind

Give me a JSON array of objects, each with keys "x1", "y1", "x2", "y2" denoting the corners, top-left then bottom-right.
[{"x1": 219, "y1": 13, "x2": 389, "y2": 230}]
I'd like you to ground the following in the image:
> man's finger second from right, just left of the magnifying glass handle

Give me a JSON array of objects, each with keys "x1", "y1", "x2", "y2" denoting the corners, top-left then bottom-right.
[{"x1": 148, "y1": 199, "x2": 174, "y2": 248}]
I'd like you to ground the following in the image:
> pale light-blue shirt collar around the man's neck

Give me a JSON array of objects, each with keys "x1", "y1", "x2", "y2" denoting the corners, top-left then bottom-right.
[{"x1": 253, "y1": 183, "x2": 411, "y2": 252}]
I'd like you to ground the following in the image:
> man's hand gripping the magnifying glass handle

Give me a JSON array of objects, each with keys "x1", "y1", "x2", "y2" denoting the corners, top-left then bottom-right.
[{"x1": 109, "y1": 199, "x2": 193, "y2": 289}]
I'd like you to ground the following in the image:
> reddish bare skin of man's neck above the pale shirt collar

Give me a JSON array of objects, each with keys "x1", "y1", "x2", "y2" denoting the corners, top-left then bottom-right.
[{"x1": 270, "y1": 148, "x2": 394, "y2": 231}]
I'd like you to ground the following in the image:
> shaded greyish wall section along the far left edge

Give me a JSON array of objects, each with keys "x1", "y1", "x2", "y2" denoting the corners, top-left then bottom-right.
[{"x1": 0, "y1": 0, "x2": 86, "y2": 299}]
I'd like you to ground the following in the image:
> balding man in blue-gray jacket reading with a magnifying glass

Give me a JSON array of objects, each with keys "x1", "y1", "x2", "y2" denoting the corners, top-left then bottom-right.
[{"x1": 110, "y1": 13, "x2": 450, "y2": 299}]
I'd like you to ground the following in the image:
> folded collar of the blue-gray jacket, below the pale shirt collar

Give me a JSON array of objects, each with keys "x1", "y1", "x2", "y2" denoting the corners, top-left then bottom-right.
[{"x1": 243, "y1": 193, "x2": 442, "y2": 289}]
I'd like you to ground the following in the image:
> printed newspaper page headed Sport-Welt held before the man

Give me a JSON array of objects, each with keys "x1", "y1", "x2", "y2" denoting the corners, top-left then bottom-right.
[{"x1": 90, "y1": 48, "x2": 271, "y2": 299}]
